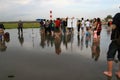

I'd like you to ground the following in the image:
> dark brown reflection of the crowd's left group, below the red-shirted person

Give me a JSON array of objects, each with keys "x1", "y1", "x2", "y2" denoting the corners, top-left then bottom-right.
[{"x1": 40, "y1": 31, "x2": 73, "y2": 55}]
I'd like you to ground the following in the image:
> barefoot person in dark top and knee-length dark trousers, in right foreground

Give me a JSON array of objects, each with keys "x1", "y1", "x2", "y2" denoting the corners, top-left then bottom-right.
[{"x1": 104, "y1": 13, "x2": 120, "y2": 78}]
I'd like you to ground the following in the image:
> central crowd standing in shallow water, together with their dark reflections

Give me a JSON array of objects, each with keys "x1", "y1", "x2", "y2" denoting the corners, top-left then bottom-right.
[{"x1": 40, "y1": 18, "x2": 102, "y2": 55}]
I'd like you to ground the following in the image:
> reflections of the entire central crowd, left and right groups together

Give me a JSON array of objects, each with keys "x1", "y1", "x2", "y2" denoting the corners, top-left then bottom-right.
[{"x1": 40, "y1": 27, "x2": 100, "y2": 58}]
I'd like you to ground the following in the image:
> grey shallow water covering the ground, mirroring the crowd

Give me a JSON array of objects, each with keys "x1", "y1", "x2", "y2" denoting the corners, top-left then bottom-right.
[{"x1": 0, "y1": 27, "x2": 117, "y2": 80}]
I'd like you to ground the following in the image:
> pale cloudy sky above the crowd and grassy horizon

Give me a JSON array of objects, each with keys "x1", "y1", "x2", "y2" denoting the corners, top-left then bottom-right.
[{"x1": 0, "y1": 0, "x2": 120, "y2": 21}]
